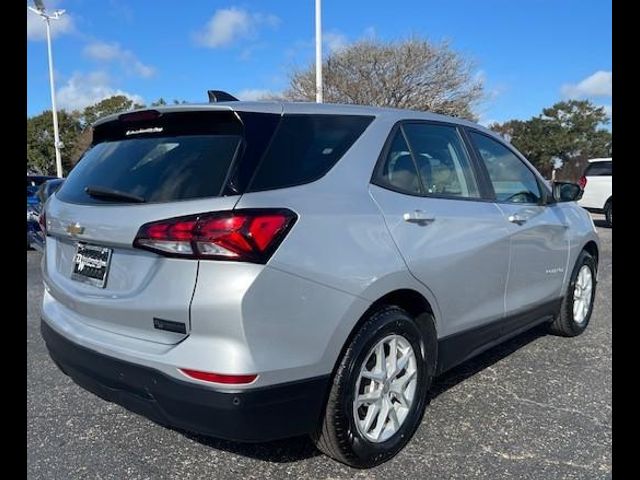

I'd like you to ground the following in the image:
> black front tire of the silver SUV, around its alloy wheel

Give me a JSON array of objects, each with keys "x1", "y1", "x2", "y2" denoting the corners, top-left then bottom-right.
[{"x1": 549, "y1": 250, "x2": 598, "y2": 337}]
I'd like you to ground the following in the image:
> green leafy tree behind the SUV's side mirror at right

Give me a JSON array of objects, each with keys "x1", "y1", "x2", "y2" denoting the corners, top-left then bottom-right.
[{"x1": 489, "y1": 100, "x2": 612, "y2": 180}]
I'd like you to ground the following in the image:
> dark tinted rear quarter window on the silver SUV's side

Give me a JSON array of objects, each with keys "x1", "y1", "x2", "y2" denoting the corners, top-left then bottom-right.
[{"x1": 248, "y1": 115, "x2": 373, "y2": 192}]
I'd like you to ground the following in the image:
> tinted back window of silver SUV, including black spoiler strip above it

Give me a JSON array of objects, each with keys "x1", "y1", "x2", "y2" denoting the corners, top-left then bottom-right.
[{"x1": 57, "y1": 111, "x2": 248, "y2": 204}]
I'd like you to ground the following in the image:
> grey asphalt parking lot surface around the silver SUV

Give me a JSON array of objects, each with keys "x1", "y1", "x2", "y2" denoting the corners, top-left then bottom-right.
[{"x1": 27, "y1": 217, "x2": 612, "y2": 480}]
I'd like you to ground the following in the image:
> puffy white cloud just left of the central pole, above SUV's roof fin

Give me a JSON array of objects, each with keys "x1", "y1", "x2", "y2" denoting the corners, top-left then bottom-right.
[{"x1": 195, "y1": 7, "x2": 280, "y2": 48}]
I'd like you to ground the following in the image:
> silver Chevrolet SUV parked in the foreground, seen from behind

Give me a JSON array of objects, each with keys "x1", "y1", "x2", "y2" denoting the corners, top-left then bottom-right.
[{"x1": 42, "y1": 102, "x2": 598, "y2": 467}]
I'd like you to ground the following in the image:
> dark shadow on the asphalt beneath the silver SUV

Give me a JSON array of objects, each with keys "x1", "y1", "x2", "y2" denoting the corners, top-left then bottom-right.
[{"x1": 171, "y1": 324, "x2": 547, "y2": 463}]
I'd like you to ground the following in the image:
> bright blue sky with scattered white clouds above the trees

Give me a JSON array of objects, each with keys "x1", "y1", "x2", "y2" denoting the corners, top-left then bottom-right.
[{"x1": 27, "y1": 0, "x2": 611, "y2": 124}]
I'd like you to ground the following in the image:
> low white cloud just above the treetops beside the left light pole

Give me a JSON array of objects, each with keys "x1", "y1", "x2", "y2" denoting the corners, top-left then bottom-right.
[{"x1": 56, "y1": 72, "x2": 144, "y2": 110}]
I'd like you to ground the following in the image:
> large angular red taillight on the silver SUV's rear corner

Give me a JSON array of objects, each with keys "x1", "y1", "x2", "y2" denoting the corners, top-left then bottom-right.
[{"x1": 133, "y1": 209, "x2": 297, "y2": 263}]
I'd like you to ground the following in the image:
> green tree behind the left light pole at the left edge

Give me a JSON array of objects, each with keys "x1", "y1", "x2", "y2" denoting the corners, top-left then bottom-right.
[{"x1": 27, "y1": 110, "x2": 82, "y2": 175}]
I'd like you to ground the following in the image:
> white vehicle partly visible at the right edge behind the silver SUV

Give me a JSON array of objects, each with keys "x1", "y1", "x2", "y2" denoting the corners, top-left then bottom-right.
[{"x1": 579, "y1": 158, "x2": 613, "y2": 227}]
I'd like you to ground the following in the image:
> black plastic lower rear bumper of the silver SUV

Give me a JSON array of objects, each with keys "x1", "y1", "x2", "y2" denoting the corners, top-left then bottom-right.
[{"x1": 41, "y1": 321, "x2": 329, "y2": 442}]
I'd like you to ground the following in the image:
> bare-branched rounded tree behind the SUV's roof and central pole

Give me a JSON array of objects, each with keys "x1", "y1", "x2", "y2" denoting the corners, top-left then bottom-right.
[{"x1": 282, "y1": 37, "x2": 483, "y2": 119}]
